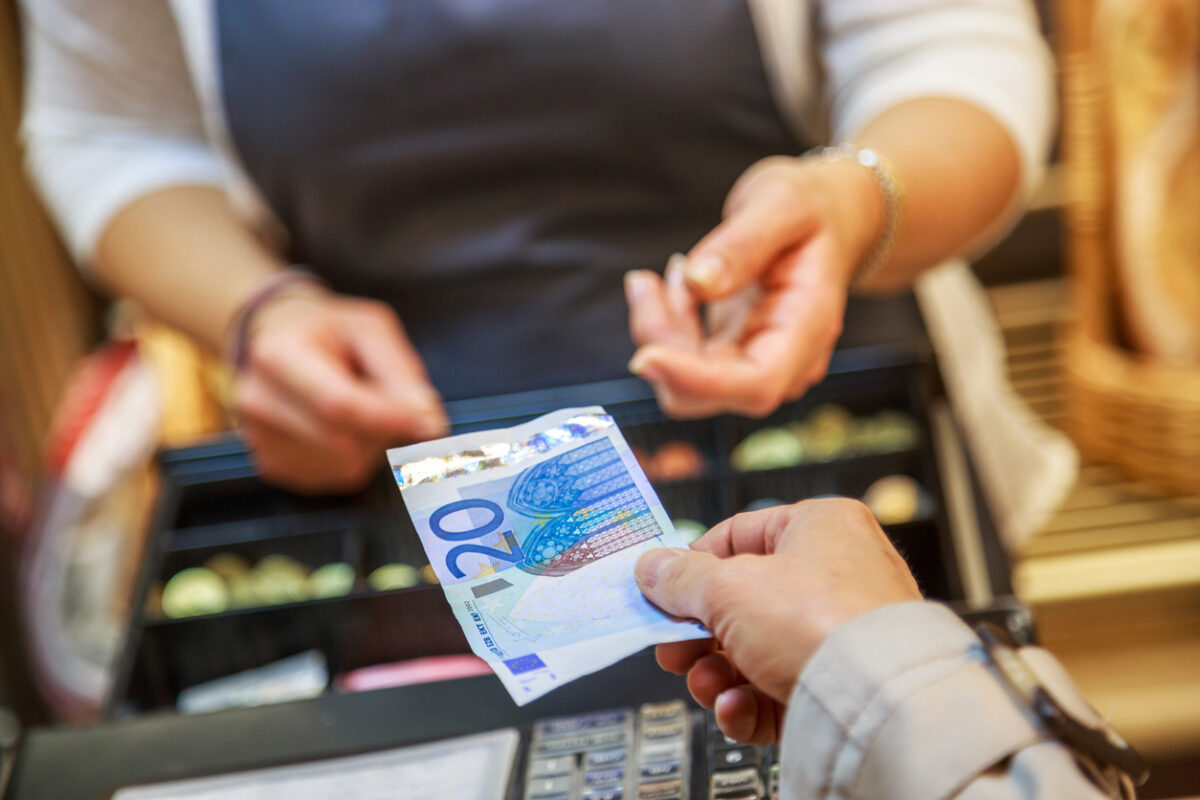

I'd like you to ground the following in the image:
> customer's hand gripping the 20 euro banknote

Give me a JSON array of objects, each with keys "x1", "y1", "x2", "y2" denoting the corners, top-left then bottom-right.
[{"x1": 636, "y1": 499, "x2": 922, "y2": 744}]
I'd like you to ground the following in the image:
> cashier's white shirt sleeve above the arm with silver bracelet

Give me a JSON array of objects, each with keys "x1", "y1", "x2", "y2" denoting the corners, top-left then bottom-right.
[{"x1": 817, "y1": 0, "x2": 1055, "y2": 204}]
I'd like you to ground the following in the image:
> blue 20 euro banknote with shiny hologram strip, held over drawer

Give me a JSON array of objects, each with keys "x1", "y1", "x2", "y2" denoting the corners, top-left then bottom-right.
[{"x1": 388, "y1": 407, "x2": 708, "y2": 705}]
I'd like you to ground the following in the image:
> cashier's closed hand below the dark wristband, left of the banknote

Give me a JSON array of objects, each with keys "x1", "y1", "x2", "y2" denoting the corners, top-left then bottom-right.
[{"x1": 234, "y1": 287, "x2": 446, "y2": 494}]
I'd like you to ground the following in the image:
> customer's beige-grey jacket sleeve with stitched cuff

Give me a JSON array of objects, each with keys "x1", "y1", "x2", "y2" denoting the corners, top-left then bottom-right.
[{"x1": 781, "y1": 602, "x2": 1109, "y2": 800}]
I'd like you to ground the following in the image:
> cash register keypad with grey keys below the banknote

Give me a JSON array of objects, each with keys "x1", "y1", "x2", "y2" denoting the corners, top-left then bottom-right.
[{"x1": 523, "y1": 700, "x2": 779, "y2": 800}]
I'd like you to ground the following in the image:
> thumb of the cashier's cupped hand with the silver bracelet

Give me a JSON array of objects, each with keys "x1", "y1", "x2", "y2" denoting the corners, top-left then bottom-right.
[{"x1": 685, "y1": 182, "x2": 815, "y2": 301}]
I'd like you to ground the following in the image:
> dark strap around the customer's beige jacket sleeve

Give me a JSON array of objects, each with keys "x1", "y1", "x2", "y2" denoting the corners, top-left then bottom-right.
[{"x1": 974, "y1": 622, "x2": 1150, "y2": 798}]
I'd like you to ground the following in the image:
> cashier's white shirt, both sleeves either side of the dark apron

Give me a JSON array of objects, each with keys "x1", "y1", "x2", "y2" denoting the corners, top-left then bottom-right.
[{"x1": 16, "y1": 0, "x2": 1054, "y2": 264}]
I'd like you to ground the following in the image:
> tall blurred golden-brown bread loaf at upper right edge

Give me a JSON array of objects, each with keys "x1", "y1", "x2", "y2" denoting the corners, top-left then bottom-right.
[{"x1": 1096, "y1": 0, "x2": 1200, "y2": 363}]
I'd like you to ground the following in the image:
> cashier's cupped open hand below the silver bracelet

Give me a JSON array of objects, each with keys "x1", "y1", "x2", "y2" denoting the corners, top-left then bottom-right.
[{"x1": 625, "y1": 156, "x2": 884, "y2": 417}]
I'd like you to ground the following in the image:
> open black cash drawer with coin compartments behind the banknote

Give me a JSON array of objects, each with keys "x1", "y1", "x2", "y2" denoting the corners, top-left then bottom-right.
[{"x1": 109, "y1": 362, "x2": 993, "y2": 715}]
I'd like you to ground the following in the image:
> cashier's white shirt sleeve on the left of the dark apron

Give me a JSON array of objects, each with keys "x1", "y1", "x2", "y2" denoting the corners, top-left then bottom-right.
[{"x1": 22, "y1": 0, "x2": 227, "y2": 264}]
